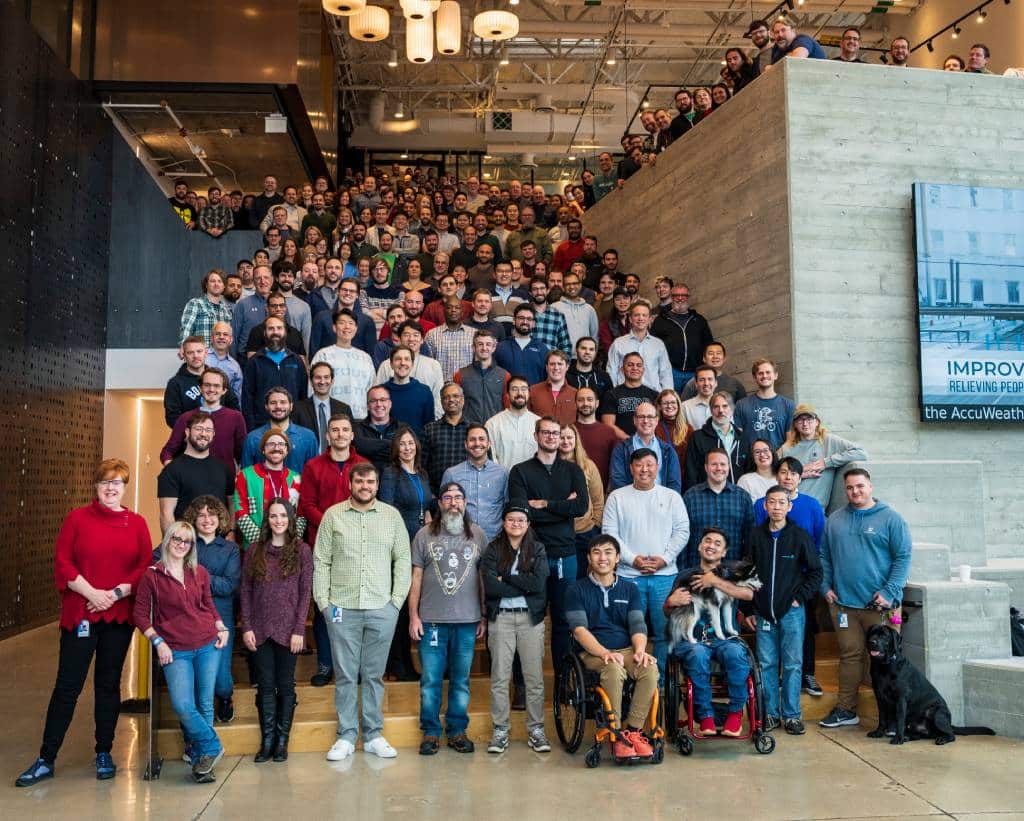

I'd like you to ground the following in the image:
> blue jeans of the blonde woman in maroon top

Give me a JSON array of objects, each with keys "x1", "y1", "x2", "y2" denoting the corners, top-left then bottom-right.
[{"x1": 164, "y1": 642, "x2": 223, "y2": 755}]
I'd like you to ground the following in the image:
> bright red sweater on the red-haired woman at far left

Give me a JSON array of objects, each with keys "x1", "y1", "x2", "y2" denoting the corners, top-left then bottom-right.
[{"x1": 53, "y1": 500, "x2": 153, "y2": 630}]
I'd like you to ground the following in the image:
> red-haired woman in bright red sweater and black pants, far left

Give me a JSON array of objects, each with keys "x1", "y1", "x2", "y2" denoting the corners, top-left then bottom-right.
[{"x1": 16, "y1": 459, "x2": 153, "y2": 787}]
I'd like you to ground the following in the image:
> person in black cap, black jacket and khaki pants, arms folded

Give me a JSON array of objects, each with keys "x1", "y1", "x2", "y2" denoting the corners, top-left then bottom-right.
[{"x1": 480, "y1": 505, "x2": 551, "y2": 753}]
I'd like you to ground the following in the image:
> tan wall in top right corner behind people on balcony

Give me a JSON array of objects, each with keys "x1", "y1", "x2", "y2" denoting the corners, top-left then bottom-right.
[{"x1": 886, "y1": 0, "x2": 1024, "y2": 74}]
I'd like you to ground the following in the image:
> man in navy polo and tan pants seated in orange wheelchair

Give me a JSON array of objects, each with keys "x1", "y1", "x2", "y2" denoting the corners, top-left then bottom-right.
[{"x1": 565, "y1": 535, "x2": 657, "y2": 759}]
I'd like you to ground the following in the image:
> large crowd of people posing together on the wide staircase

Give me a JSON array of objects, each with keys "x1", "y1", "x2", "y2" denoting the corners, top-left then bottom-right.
[{"x1": 18, "y1": 161, "x2": 909, "y2": 785}]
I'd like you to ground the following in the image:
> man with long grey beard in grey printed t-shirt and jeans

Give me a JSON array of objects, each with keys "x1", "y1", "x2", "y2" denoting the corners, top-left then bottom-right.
[{"x1": 409, "y1": 482, "x2": 487, "y2": 755}]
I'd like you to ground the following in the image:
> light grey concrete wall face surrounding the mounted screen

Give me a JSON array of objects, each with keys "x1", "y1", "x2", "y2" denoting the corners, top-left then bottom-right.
[{"x1": 786, "y1": 60, "x2": 1024, "y2": 556}]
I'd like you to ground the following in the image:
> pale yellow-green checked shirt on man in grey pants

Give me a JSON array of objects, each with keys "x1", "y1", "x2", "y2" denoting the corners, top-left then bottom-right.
[{"x1": 313, "y1": 500, "x2": 413, "y2": 610}]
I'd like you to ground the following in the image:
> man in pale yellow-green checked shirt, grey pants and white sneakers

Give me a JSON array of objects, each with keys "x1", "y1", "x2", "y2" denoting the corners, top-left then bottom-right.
[{"x1": 313, "y1": 463, "x2": 412, "y2": 762}]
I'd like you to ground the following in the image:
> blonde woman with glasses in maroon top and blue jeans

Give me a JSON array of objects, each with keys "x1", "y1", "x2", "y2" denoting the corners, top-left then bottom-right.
[{"x1": 135, "y1": 522, "x2": 228, "y2": 784}]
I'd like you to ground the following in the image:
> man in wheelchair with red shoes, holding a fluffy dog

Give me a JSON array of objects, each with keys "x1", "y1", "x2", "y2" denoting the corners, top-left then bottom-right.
[{"x1": 665, "y1": 527, "x2": 754, "y2": 737}]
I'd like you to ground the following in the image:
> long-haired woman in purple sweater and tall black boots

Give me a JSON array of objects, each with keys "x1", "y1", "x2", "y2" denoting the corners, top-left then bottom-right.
[{"x1": 241, "y1": 498, "x2": 313, "y2": 763}]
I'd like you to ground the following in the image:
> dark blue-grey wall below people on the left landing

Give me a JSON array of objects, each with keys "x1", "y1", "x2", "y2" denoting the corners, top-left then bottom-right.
[{"x1": 108, "y1": 137, "x2": 263, "y2": 348}]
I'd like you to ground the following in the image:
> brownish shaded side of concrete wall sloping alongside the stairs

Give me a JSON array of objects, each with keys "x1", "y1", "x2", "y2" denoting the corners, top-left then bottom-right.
[{"x1": 586, "y1": 64, "x2": 793, "y2": 392}]
